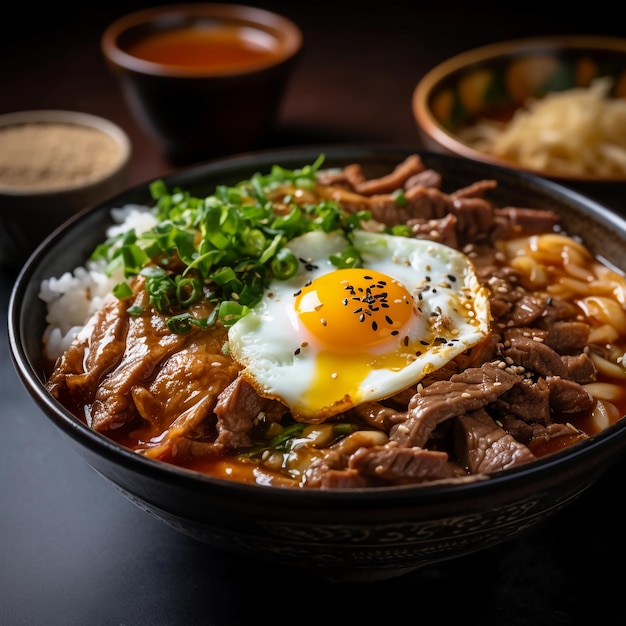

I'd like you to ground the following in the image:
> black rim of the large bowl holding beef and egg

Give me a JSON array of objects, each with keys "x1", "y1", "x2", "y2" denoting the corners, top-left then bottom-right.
[{"x1": 7, "y1": 145, "x2": 626, "y2": 502}]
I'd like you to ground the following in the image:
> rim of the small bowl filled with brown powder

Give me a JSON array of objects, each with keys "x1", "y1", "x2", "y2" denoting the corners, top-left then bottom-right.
[{"x1": 0, "y1": 109, "x2": 132, "y2": 198}]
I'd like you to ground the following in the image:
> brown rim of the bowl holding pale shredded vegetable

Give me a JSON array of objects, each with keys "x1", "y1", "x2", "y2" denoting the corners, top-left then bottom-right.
[{"x1": 411, "y1": 35, "x2": 626, "y2": 185}]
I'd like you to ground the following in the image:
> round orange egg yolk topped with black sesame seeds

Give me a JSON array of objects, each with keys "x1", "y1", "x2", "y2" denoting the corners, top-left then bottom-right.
[{"x1": 295, "y1": 268, "x2": 416, "y2": 351}]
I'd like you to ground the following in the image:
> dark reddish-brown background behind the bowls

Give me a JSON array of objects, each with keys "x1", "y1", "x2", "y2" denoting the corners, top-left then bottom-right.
[{"x1": 0, "y1": 0, "x2": 626, "y2": 183}]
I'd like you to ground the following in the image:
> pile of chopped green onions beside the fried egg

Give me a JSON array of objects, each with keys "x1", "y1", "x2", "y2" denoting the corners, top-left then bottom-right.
[{"x1": 92, "y1": 155, "x2": 382, "y2": 332}]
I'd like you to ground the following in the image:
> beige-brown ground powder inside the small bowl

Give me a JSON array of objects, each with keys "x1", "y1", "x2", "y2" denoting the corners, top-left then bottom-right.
[{"x1": 0, "y1": 122, "x2": 121, "y2": 191}]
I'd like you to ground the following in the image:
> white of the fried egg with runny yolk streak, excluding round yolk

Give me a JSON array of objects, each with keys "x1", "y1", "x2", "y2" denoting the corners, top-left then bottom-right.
[{"x1": 229, "y1": 230, "x2": 491, "y2": 422}]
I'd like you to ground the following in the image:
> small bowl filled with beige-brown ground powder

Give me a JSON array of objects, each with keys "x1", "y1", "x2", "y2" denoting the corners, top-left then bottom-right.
[{"x1": 0, "y1": 110, "x2": 132, "y2": 271}]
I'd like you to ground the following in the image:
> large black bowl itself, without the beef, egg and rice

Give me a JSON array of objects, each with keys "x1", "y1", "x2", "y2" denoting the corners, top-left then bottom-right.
[{"x1": 8, "y1": 146, "x2": 626, "y2": 581}]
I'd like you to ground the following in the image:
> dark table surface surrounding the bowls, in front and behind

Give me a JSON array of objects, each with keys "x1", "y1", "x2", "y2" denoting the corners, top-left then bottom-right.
[{"x1": 0, "y1": 0, "x2": 626, "y2": 626}]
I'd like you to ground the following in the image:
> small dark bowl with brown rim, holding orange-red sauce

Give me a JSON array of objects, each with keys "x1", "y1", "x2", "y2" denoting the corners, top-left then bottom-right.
[{"x1": 101, "y1": 3, "x2": 302, "y2": 164}]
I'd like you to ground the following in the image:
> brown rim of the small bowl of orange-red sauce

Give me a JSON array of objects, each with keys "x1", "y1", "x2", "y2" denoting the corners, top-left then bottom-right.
[{"x1": 100, "y1": 2, "x2": 303, "y2": 79}]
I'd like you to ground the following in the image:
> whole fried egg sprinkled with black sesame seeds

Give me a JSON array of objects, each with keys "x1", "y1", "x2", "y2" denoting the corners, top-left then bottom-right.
[{"x1": 229, "y1": 230, "x2": 491, "y2": 423}]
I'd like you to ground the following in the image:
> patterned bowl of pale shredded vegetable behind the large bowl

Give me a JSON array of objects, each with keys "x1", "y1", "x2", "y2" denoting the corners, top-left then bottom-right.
[{"x1": 412, "y1": 35, "x2": 626, "y2": 209}]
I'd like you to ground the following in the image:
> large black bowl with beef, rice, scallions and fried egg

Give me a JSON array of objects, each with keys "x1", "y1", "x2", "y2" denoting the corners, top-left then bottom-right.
[{"x1": 9, "y1": 146, "x2": 626, "y2": 580}]
